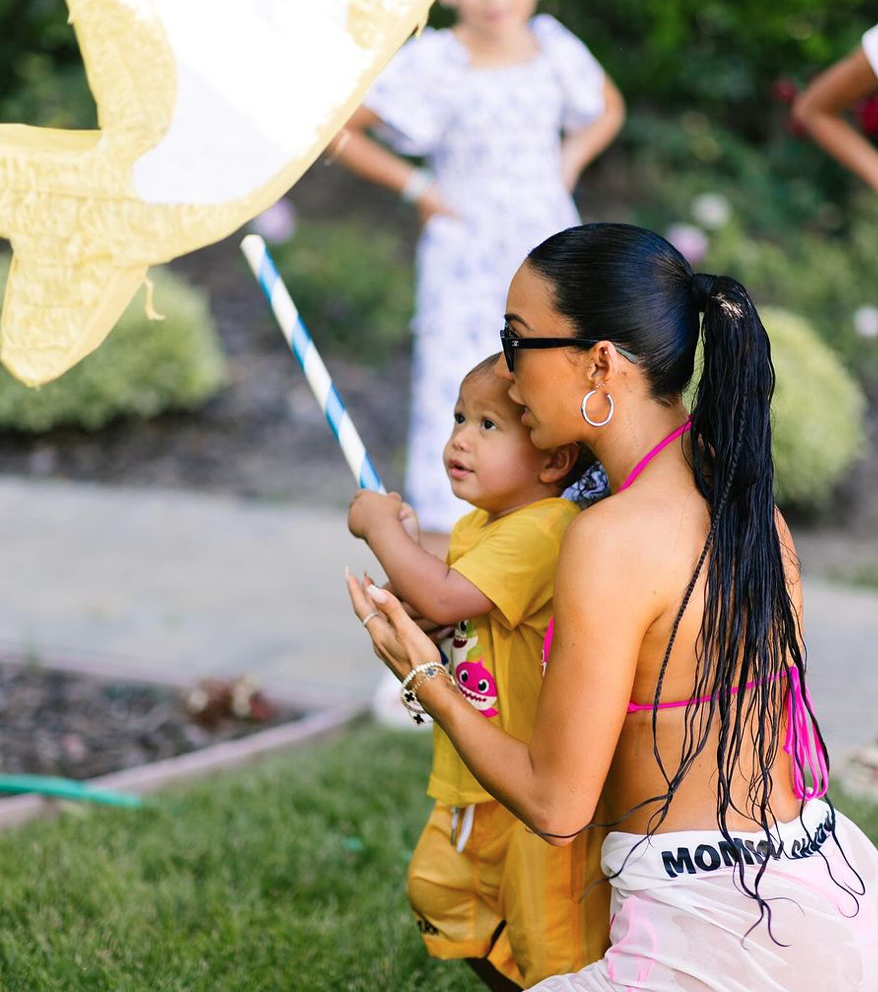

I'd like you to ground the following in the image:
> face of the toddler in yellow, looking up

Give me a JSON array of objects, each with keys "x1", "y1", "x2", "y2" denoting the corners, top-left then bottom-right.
[{"x1": 444, "y1": 370, "x2": 546, "y2": 513}]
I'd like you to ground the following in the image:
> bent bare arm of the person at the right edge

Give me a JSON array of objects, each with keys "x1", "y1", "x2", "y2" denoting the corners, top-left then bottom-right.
[{"x1": 793, "y1": 46, "x2": 878, "y2": 191}]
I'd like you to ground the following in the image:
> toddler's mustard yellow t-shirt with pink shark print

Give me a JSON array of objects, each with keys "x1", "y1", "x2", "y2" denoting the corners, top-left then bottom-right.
[{"x1": 427, "y1": 498, "x2": 579, "y2": 806}]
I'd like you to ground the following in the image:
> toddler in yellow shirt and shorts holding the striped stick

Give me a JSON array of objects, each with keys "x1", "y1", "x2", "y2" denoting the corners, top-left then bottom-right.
[{"x1": 348, "y1": 357, "x2": 609, "y2": 989}]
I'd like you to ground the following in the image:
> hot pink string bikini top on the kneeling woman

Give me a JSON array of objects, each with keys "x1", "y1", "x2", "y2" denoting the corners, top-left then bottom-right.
[{"x1": 543, "y1": 420, "x2": 829, "y2": 799}]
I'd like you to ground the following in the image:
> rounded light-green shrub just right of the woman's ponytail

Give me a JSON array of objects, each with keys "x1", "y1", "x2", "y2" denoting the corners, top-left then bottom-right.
[{"x1": 688, "y1": 307, "x2": 866, "y2": 512}]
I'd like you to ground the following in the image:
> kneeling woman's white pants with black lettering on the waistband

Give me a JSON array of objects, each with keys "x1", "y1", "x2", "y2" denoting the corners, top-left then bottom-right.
[{"x1": 533, "y1": 801, "x2": 878, "y2": 992}]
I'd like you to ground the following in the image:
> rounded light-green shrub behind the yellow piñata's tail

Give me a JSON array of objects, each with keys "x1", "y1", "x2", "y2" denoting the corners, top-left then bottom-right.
[{"x1": 0, "y1": 257, "x2": 225, "y2": 433}]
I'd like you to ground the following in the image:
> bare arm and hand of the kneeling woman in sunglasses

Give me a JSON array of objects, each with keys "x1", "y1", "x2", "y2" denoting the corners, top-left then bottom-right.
[{"x1": 348, "y1": 507, "x2": 654, "y2": 845}]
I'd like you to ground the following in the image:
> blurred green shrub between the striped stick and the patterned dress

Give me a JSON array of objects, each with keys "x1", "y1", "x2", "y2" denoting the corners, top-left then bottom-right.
[{"x1": 272, "y1": 220, "x2": 414, "y2": 362}]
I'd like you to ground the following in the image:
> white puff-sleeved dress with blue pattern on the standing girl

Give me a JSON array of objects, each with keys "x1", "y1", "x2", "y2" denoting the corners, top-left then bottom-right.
[{"x1": 366, "y1": 15, "x2": 604, "y2": 532}]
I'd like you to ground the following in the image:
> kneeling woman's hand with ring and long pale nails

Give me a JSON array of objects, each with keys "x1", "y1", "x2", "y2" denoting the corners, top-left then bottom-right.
[{"x1": 345, "y1": 570, "x2": 441, "y2": 681}]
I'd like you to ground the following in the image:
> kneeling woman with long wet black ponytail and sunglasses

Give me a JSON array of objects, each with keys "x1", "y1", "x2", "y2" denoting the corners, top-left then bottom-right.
[{"x1": 349, "y1": 224, "x2": 878, "y2": 992}]
